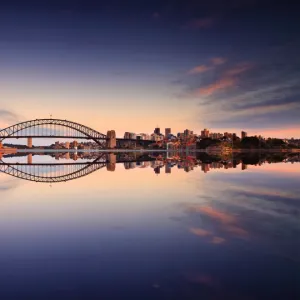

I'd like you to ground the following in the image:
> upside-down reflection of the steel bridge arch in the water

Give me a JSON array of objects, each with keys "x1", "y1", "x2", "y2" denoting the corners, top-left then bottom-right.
[{"x1": 0, "y1": 155, "x2": 107, "y2": 183}]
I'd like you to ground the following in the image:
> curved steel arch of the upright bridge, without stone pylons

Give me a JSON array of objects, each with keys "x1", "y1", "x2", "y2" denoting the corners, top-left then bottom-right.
[{"x1": 0, "y1": 119, "x2": 107, "y2": 148}]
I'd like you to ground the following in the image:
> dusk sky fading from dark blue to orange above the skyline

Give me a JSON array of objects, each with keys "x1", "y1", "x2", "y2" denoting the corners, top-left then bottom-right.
[{"x1": 0, "y1": 0, "x2": 300, "y2": 138}]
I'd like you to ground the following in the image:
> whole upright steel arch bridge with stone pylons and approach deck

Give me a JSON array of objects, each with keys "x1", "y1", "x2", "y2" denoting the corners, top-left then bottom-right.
[{"x1": 0, "y1": 119, "x2": 152, "y2": 149}]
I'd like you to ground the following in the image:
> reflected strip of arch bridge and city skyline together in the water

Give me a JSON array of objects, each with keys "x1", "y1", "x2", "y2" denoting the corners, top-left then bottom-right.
[{"x1": 0, "y1": 152, "x2": 300, "y2": 183}]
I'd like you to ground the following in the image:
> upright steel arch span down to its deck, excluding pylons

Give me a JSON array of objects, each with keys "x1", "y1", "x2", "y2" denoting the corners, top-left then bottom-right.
[{"x1": 0, "y1": 119, "x2": 107, "y2": 148}]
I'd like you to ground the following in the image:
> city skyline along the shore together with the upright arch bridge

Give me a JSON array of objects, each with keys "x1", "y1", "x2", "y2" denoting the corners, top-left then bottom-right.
[{"x1": 0, "y1": 118, "x2": 300, "y2": 150}]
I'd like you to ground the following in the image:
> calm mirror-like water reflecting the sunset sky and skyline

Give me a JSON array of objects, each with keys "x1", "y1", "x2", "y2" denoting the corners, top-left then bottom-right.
[{"x1": 0, "y1": 153, "x2": 300, "y2": 300}]
